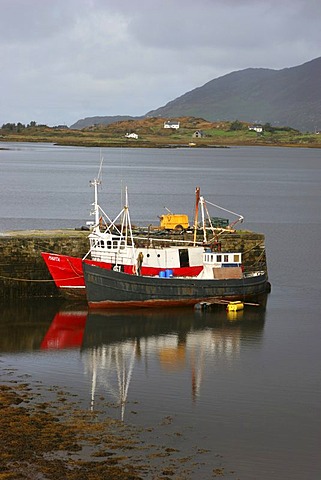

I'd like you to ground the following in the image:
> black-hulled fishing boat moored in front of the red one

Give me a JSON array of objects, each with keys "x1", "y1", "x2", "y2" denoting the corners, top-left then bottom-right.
[{"x1": 83, "y1": 251, "x2": 269, "y2": 308}]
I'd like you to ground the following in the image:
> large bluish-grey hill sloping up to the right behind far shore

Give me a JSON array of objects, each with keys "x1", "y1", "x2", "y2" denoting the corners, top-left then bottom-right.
[{"x1": 147, "y1": 57, "x2": 321, "y2": 131}]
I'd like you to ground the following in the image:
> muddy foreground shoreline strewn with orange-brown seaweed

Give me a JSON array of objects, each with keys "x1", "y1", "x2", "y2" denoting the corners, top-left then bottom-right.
[{"x1": 0, "y1": 369, "x2": 228, "y2": 480}]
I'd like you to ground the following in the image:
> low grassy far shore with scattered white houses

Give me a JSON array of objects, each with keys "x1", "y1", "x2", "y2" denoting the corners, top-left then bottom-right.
[{"x1": 0, "y1": 117, "x2": 321, "y2": 148}]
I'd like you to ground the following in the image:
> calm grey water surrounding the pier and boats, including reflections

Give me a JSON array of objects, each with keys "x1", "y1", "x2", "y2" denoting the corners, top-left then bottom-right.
[{"x1": 0, "y1": 144, "x2": 321, "y2": 480}]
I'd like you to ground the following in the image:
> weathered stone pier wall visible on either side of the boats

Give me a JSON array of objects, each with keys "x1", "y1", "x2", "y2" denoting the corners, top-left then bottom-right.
[{"x1": 0, "y1": 230, "x2": 267, "y2": 301}]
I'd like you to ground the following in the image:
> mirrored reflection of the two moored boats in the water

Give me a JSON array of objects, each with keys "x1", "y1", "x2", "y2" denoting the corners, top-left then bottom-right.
[{"x1": 42, "y1": 300, "x2": 265, "y2": 419}]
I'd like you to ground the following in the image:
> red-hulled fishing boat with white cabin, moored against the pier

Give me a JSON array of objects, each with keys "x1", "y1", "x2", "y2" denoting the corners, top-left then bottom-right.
[{"x1": 41, "y1": 162, "x2": 243, "y2": 297}]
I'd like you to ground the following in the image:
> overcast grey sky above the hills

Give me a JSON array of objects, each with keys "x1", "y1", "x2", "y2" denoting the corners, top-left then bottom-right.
[{"x1": 0, "y1": 0, "x2": 321, "y2": 126}]
